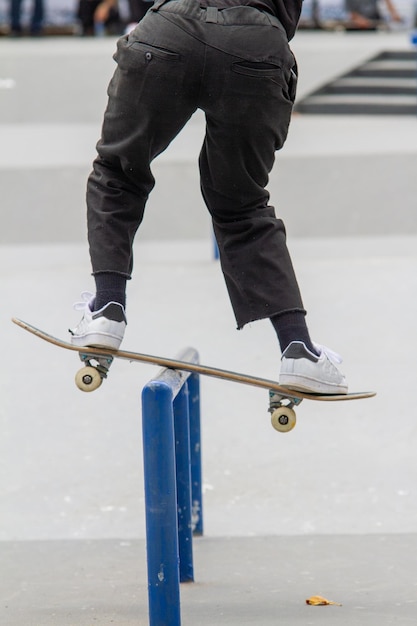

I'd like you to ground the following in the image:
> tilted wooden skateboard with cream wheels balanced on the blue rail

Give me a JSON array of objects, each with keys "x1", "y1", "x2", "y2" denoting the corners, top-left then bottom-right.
[{"x1": 12, "y1": 318, "x2": 376, "y2": 432}]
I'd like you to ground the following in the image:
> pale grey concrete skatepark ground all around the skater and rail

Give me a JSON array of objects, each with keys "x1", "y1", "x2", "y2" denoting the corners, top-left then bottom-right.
[{"x1": 0, "y1": 26, "x2": 417, "y2": 626}]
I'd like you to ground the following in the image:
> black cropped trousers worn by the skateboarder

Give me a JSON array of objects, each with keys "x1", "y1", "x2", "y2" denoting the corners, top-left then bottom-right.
[{"x1": 87, "y1": 0, "x2": 303, "y2": 328}]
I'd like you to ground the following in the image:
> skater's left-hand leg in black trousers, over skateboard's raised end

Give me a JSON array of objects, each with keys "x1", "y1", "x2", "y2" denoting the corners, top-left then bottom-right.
[{"x1": 72, "y1": 13, "x2": 204, "y2": 347}]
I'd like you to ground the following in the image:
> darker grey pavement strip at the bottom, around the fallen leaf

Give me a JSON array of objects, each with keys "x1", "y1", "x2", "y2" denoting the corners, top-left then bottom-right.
[{"x1": 2, "y1": 534, "x2": 417, "y2": 626}]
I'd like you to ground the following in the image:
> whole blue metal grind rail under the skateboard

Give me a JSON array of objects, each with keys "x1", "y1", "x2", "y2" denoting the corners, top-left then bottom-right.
[{"x1": 142, "y1": 348, "x2": 203, "y2": 626}]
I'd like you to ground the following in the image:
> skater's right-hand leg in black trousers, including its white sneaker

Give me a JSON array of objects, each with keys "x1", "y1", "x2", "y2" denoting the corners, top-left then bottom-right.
[{"x1": 200, "y1": 9, "x2": 347, "y2": 393}]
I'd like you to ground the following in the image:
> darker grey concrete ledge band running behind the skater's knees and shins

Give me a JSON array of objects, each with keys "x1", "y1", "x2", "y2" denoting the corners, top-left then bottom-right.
[{"x1": 0, "y1": 153, "x2": 417, "y2": 244}]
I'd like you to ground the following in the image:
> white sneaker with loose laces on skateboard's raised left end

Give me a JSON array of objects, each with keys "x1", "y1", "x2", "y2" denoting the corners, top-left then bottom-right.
[{"x1": 70, "y1": 291, "x2": 127, "y2": 350}]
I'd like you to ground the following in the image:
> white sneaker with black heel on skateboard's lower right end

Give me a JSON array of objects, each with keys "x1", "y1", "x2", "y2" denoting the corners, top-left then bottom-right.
[{"x1": 279, "y1": 341, "x2": 348, "y2": 394}]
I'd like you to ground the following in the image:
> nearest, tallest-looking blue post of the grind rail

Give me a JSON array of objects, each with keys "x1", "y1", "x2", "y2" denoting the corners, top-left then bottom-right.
[{"x1": 142, "y1": 381, "x2": 181, "y2": 626}]
